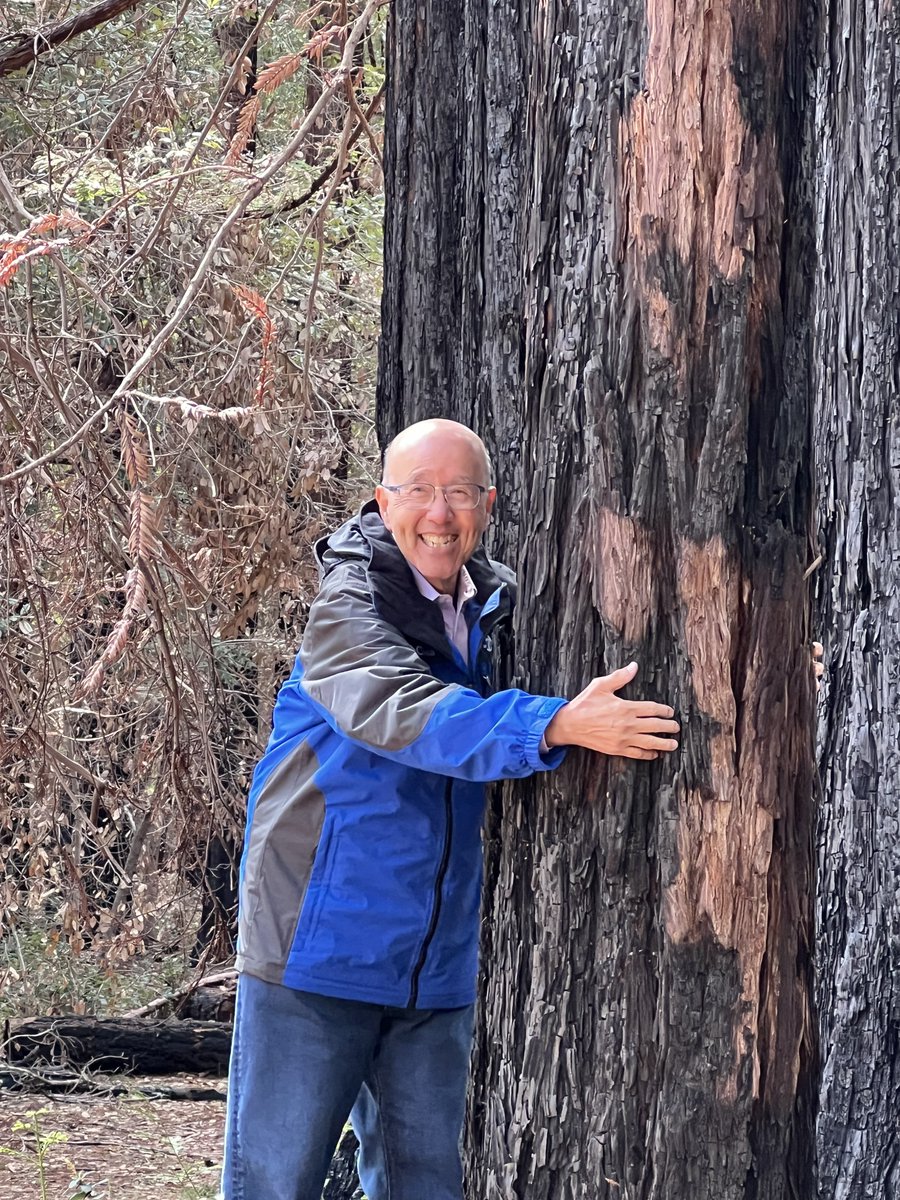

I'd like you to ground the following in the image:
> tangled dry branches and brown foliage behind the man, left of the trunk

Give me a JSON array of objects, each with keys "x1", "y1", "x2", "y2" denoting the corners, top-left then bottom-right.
[{"x1": 0, "y1": 0, "x2": 385, "y2": 1195}]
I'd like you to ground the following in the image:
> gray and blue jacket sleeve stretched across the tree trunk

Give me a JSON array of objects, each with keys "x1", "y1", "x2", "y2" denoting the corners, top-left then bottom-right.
[{"x1": 294, "y1": 568, "x2": 565, "y2": 781}]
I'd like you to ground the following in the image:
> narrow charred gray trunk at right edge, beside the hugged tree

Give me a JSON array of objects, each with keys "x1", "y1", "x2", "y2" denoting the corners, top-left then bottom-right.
[{"x1": 812, "y1": 0, "x2": 900, "y2": 1200}]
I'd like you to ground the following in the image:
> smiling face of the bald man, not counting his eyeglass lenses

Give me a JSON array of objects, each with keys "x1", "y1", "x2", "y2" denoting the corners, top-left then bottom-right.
[{"x1": 376, "y1": 432, "x2": 497, "y2": 595}]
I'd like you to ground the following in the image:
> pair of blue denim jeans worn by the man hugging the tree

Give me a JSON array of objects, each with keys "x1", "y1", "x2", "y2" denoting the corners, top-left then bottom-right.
[{"x1": 222, "y1": 974, "x2": 473, "y2": 1200}]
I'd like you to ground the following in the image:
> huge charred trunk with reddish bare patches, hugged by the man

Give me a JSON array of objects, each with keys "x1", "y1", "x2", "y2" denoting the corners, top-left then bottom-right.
[{"x1": 379, "y1": 0, "x2": 815, "y2": 1200}]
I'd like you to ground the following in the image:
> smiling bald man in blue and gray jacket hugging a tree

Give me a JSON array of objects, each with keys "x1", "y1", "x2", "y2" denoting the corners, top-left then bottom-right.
[{"x1": 223, "y1": 420, "x2": 678, "y2": 1200}]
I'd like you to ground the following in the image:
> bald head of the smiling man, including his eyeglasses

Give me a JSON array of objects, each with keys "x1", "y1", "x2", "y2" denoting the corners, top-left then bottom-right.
[{"x1": 376, "y1": 419, "x2": 497, "y2": 594}]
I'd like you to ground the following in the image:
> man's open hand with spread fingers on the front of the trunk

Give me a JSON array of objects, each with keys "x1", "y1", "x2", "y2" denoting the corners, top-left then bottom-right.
[{"x1": 544, "y1": 662, "x2": 680, "y2": 758}]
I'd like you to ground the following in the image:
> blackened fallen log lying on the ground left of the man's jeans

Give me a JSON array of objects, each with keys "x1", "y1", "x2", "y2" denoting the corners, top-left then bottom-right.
[{"x1": 4, "y1": 1016, "x2": 232, "y2": 1076}]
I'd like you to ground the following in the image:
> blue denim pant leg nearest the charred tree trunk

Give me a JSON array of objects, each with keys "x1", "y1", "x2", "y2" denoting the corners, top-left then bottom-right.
[{"x1": 350, "y1": 1006, "x2": 474, "y2": 1200}]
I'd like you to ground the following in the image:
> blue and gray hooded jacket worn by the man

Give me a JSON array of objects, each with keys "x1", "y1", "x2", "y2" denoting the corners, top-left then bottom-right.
[{"x1": 238, "y1": 503, "x2": 565, "y2": 1008}]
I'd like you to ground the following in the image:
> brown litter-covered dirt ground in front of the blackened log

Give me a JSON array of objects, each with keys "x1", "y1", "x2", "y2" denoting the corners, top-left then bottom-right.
[{"x1": 0, "y1": 1075, "x2": 224, "y2": 1200}]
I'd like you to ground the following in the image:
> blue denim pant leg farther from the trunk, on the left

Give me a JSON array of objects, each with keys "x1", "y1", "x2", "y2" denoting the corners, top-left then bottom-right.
[{"x1": 222, "y1": 974, "x2": 384, "y2": 1200}]
